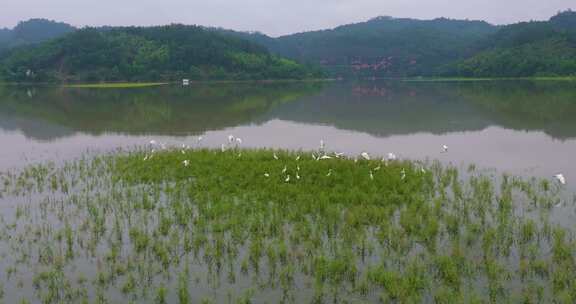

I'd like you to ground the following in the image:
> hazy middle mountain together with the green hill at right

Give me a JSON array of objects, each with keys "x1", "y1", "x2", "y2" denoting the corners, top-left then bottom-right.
[{"x1": 230, "y1": 11, "x2": 576, "y2": 78}]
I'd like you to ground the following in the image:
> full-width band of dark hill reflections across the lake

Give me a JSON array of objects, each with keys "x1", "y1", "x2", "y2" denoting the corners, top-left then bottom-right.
[{"x1": 0, "y1": 81, "x2": 576, "y2": 139}]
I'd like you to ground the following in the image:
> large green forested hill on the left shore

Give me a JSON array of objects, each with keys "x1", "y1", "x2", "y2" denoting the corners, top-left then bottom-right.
[{"x1": 0, "y1": 25, "x2": 321, "y2": 82}]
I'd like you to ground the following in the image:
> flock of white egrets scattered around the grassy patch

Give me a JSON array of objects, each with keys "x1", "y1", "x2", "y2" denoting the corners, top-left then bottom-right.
[{"x1": 144, "y1": 135, "x2": 566, "y2": 185}]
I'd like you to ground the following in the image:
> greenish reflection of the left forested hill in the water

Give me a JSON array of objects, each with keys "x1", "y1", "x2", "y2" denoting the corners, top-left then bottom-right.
[{"x1": 0, "y1": 83, "x2": 320, "y2": 138}]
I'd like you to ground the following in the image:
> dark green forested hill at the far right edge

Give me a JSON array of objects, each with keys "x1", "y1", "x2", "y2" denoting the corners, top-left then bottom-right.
[{"x1": 450, "y1": 11, "x2": 576, "y2": 77}]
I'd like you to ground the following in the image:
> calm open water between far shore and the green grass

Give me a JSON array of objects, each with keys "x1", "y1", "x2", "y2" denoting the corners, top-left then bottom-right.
[{"x1": 0, "y1": 81, "x2": 576, "y2": 190}]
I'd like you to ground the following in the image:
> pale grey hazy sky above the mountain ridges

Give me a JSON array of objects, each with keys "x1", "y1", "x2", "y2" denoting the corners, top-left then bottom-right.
[{"x1": 0, "y1": 0, "x2": 576, "y2": 36}]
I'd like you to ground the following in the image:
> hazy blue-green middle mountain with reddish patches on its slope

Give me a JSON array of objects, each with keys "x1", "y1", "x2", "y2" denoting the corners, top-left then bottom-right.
[{"x1": 232, "y1": 17, "x2": 498, "y2": 77}]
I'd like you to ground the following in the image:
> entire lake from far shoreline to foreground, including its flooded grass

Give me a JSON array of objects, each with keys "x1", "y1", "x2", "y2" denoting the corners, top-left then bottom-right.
[{"x1": 0, "y1": 81, "x2": 576, "y2": 303}]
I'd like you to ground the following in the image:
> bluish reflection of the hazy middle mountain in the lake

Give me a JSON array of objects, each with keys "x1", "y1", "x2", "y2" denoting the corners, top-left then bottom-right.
[{"x1": 270, "y1": 83, "x2": 489, "y2": 136}]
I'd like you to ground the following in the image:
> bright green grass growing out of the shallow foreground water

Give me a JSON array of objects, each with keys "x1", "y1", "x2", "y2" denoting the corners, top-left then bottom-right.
[{"x1": 0, "y1": 145, "x2": 576, "y2": 303}]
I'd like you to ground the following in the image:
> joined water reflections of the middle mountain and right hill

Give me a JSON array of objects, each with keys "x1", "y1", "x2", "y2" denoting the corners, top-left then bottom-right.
[{"x1": 267, "y1": 81, "x2": 576, "y2": 138}]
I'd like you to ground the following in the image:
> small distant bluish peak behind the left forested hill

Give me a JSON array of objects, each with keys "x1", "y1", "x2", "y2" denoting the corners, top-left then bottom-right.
[{"x1": 0, "y1": 19, "x2": 76, "y2": 49}]
